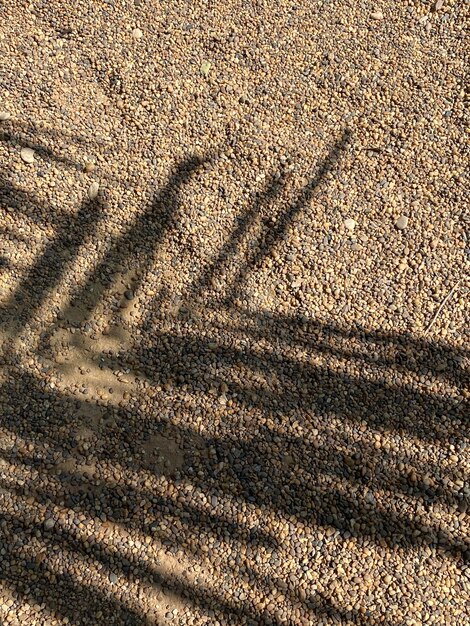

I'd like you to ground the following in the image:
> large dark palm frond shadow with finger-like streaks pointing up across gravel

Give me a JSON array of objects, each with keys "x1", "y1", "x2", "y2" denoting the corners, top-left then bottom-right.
[{"x1": 0, "y1": 133, "x2": 470, "y2": 626}]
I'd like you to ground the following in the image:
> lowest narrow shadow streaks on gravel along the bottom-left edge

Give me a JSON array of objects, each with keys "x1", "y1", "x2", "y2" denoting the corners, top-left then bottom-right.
[{"x1": 0, "y1": 502, "x2": 404, "y2": 626}]
